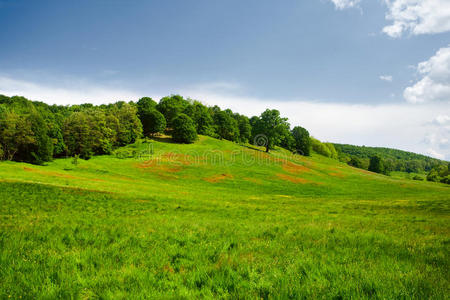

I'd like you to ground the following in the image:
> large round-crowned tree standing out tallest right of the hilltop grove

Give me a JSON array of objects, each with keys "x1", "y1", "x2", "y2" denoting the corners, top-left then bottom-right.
[{"x1": 254, "y1": 109, "x2": 289, "y2": 152}]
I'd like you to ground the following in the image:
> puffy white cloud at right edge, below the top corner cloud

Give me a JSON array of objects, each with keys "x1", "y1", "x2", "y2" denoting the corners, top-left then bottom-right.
[{"x1": 403, "y1": 46, "x2": 450, "y2": 103}]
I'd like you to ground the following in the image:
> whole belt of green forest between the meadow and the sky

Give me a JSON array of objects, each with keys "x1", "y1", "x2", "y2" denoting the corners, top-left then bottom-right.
[{"x1": 0, "y1": 95, "x2": 450, "y2": 183}]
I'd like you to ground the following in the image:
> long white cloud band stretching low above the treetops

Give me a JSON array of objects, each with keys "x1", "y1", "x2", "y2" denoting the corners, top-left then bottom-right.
[{"x1": 0, "y1": 76, "x2": 450, "y2": 159}]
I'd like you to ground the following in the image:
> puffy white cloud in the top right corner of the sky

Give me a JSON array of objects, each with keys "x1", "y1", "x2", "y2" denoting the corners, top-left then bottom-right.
[{"x1": 383, "y1": 0, "x2": 450, "y2": 38}]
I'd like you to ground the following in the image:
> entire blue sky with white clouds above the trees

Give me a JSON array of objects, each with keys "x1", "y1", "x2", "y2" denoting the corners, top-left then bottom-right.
[{"x1": 0, "y1": 0, "x2": 450, "y2": 160}]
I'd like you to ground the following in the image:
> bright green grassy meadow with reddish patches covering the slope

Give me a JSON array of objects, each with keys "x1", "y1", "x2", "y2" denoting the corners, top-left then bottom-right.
[{"x1": 0, "y1": 137, "x2": 450, "y2": 299}]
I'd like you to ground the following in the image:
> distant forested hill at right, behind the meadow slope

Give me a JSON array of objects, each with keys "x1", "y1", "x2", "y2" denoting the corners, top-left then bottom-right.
[{"x1": 333, "y1": 143, "x2": 448, "y2": 173}]
